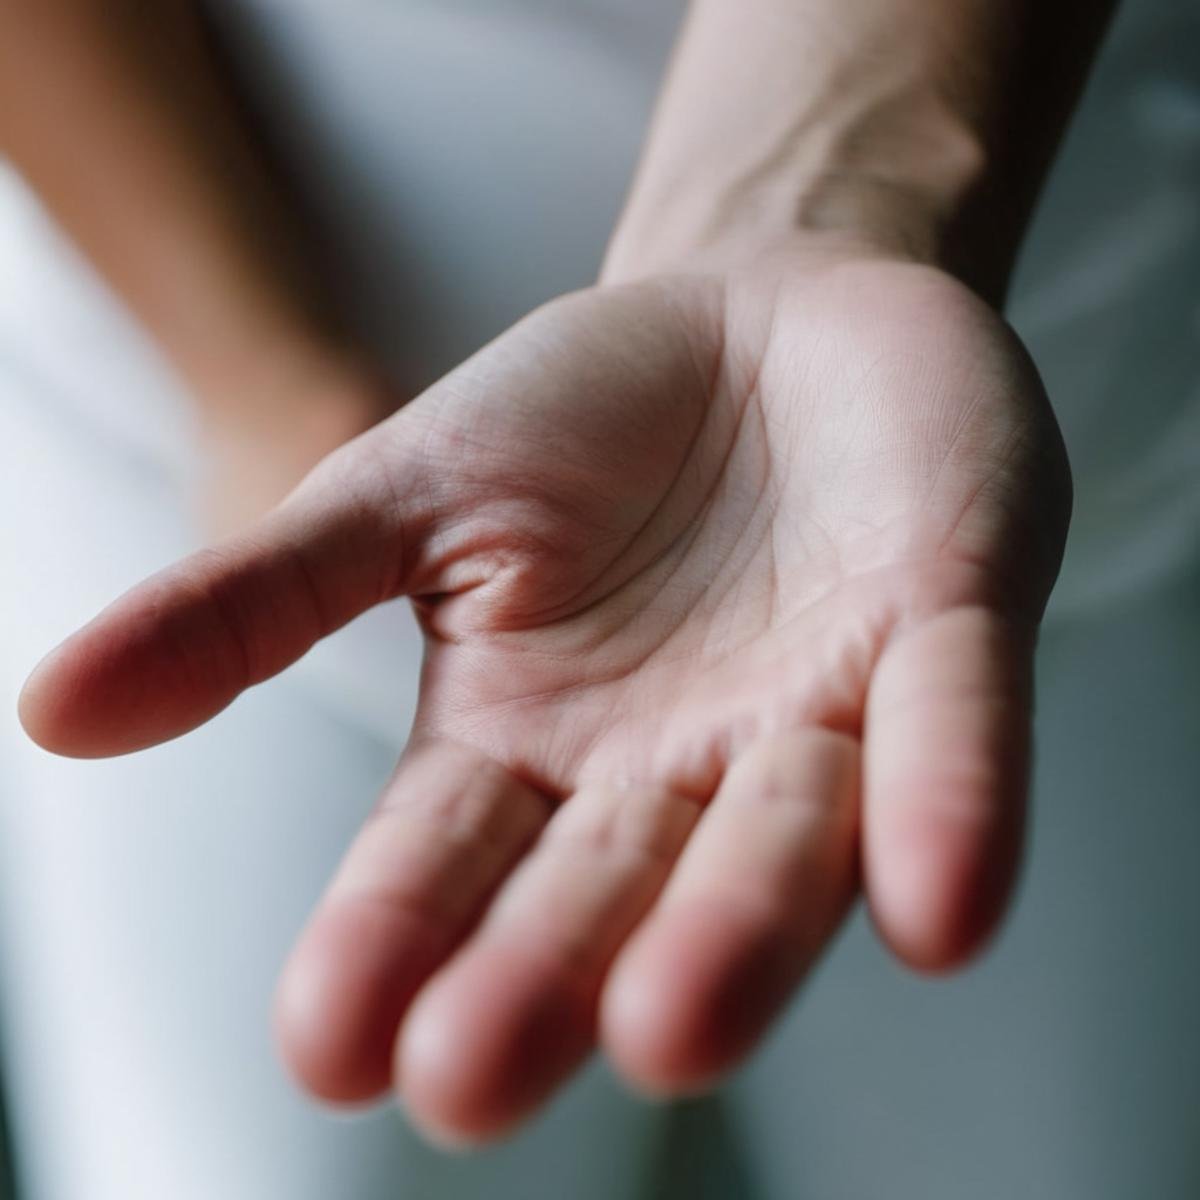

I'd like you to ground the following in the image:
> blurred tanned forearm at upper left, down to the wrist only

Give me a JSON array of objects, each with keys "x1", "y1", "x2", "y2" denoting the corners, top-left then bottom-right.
[{"x1": 0, "y1": 0, "x2": 362, "y2": 418}]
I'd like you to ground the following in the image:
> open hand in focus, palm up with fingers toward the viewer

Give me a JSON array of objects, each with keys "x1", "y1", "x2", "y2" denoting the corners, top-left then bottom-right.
[{"x1": 22, "y1": 243, "x2": 1069, "y2": 1139}]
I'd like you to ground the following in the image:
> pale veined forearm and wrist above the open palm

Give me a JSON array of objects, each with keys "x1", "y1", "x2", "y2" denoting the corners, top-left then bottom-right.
[{"x1": 605, "y1": 0, "x2": 1114, "y2": 302}]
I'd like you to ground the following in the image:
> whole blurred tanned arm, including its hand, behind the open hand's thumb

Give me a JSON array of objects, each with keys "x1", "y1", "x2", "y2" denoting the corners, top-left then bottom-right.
[{"x1": 0, "y1": 0, "x2": 393, "y2": 538}]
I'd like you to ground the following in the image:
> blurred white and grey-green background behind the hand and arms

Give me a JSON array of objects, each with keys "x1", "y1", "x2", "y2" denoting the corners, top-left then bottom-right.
[{"x1": 0, "y1": 0, "x2": 1200, "y2": 1200}]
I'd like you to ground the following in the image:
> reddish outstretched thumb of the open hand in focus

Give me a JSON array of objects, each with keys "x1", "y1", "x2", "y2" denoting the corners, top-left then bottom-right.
[{"x1": 19, "y1": 431, "x2": 427, "y2": 758}]
